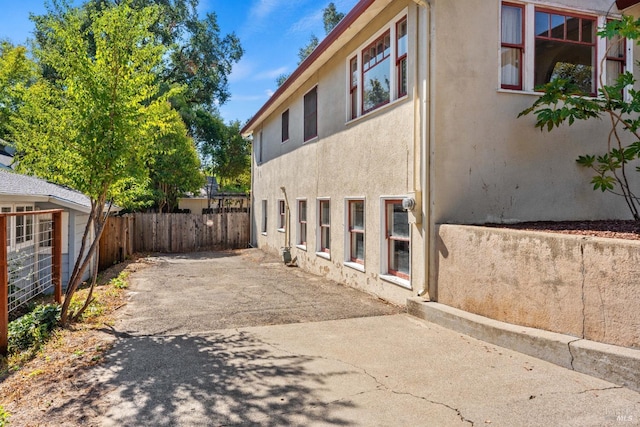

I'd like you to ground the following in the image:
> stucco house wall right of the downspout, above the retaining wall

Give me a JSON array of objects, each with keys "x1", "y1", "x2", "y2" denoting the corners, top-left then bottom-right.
[{"x1": 431, "y1": 0, "x2": 640, "y2": 223}]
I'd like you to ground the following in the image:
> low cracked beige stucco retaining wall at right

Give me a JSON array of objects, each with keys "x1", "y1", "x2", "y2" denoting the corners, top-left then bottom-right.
[{"x1": 435, "y1": 224, "x2": 640, "y2": 348}]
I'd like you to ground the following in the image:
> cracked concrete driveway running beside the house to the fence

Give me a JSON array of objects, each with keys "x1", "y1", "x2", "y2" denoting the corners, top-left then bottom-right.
[{"x1": 87, "y1": 250, "x2": 640, "y2": 426}]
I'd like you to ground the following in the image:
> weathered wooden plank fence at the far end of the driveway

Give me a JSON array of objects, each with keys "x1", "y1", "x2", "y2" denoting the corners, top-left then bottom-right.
[{"x1": 99, "y1": 212, "x2": 250, "y2": 270}]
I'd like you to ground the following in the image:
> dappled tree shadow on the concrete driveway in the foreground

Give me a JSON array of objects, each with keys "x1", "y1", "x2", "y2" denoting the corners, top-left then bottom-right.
[{"x1": 53, "y1": 331, "x2": 352, "y2": 426}]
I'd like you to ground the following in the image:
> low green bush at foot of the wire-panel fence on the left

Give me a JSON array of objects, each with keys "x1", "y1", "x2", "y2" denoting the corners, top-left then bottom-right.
[{"x1": 7, "y1": 304, "x2": 60, "y2": 354}]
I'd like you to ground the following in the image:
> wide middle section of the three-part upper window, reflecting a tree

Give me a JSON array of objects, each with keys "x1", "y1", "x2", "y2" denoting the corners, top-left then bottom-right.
[{"x1": 362, "y1": 31, "x2": 391, "y2": 113}]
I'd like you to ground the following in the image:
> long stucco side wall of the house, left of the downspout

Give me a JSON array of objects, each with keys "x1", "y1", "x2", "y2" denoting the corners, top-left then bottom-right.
[{"x1": 252, "y1": 1, "x2": 425, "y2": 304}]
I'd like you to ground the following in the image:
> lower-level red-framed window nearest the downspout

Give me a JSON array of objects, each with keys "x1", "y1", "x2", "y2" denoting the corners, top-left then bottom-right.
[{"x1": 385, "y1": 200, "x2": 410, "y2": 279}]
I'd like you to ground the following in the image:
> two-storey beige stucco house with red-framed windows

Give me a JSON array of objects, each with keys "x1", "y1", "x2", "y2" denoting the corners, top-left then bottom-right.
[{"x1": 243, "y1": 0, "x2": 640, "y2": 304}]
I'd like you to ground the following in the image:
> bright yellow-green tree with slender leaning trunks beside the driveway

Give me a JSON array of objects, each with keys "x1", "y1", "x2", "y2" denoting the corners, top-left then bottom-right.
[{"x1": 14, "y1": 0, "x2": 180, "y2": 324}]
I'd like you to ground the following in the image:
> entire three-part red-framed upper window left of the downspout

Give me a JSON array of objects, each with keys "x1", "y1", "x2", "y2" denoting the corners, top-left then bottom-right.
[{"x1": 347, "y1": 10, "x2": 409, "y2": 120}]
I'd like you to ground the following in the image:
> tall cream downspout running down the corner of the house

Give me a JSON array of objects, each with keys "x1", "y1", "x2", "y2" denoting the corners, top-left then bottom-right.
[{"x1": 413, "y1": 0, "x2": 436, "y2": 300}]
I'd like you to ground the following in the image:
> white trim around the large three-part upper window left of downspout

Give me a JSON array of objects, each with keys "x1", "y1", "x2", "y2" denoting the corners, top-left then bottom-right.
[{"x1": 345, "y1": 8, "x2": 408, "y2": 123}]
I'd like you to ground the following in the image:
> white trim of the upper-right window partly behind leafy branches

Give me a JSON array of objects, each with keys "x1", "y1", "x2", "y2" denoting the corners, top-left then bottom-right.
[{"x1": 496, "y1": 0, "x2": 634, "y2": 96}]
